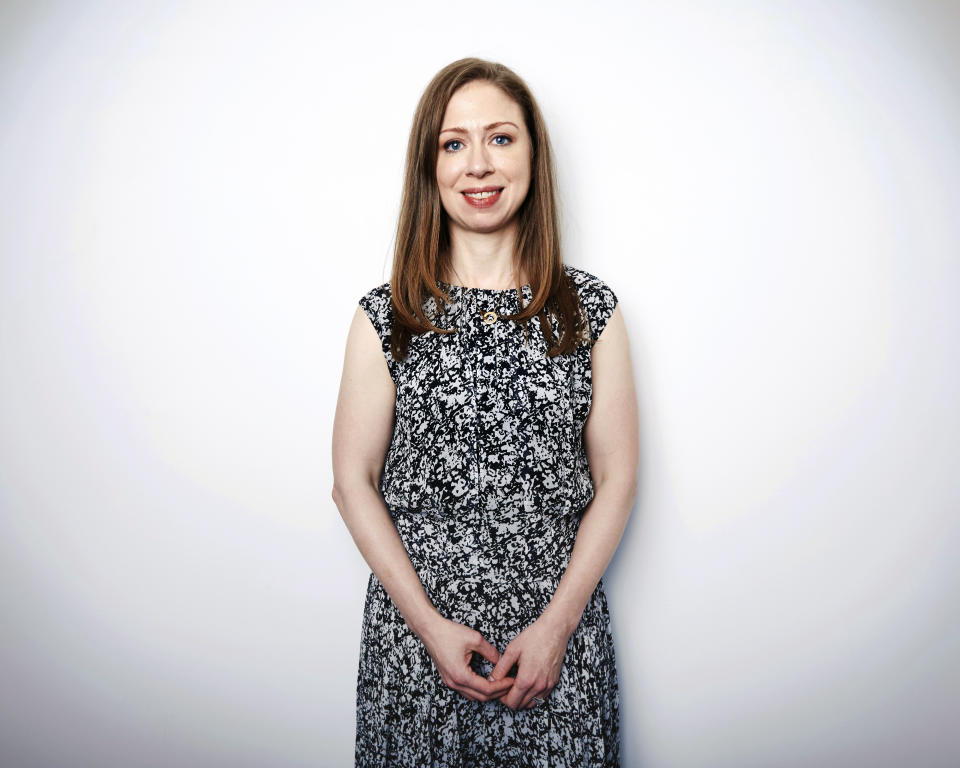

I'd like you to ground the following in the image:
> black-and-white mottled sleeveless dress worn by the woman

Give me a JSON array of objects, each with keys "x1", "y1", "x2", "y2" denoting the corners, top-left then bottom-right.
[{"x1": 355, "y1": 265, "x2": 620, "y2": 768}]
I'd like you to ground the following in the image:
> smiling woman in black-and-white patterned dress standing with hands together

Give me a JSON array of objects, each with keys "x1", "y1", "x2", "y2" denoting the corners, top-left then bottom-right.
[{"x1": 333, "y1": 58, "x2": 638, "y2": 768}]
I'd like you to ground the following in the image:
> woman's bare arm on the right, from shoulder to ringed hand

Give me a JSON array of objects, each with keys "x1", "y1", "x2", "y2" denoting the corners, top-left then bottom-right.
[{"x1": 491, "y1": 306, "x2": 640, "y2": 709}]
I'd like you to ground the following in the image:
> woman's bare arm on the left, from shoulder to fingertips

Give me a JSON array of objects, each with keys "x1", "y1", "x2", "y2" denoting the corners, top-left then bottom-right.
[{"x1": 333, "y1": 307, "x2": 512, "y2": 701}]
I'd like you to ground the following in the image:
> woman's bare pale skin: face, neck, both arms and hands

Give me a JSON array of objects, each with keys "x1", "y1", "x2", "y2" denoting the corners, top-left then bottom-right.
[{"x1": 333, "y1": 82, "x2": 639, "y2": 710}]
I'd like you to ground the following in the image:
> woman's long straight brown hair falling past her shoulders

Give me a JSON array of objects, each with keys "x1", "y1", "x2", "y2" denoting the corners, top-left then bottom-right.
[{"x1": 390, "y1": 58, "x2": 589, "y2": 360}]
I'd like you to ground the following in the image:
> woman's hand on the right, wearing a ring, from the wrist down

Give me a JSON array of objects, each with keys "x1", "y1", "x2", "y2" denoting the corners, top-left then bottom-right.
[{"x1": 489, "y1": 616, "x2": 572, "y2": 709}]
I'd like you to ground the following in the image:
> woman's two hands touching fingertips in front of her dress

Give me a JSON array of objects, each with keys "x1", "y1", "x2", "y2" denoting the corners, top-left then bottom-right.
[{"x1": 421, "y1": 615, "x2": 572, "y2": 709}]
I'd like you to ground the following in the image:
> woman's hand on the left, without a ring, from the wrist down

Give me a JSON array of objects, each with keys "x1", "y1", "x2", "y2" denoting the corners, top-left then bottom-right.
[{"x1": 421, "y1": 616, "x2": 514, "y2": 701}]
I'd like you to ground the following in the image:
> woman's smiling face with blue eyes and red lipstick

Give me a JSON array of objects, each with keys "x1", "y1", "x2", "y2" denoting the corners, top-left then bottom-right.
[{"x1": 437, "y1": 80, "x2": 533, "y2": 237}]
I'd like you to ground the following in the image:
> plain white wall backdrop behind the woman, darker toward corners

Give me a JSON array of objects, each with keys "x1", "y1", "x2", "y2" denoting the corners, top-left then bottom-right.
[{"x1": 0, "y1": 0, "x2": 960, "y2": 768}]
